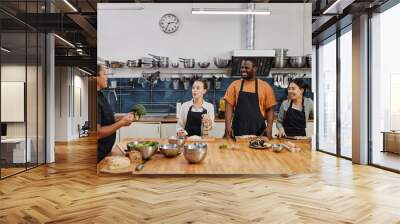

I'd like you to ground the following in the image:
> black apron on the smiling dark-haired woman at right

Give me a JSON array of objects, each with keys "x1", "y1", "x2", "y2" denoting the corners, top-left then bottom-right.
[{"x1": 283, "y1": 99, "x2": 306, "y2": 136}]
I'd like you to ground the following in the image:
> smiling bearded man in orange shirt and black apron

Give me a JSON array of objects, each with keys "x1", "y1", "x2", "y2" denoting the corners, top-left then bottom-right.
[{"x1": 224, "y1": 58, "x2": 276, "y2": 138}]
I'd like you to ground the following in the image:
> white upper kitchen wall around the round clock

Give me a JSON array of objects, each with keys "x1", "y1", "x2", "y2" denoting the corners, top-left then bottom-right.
[{"x1": 97, "y1": 3, "x2": 312, "y2": 63}]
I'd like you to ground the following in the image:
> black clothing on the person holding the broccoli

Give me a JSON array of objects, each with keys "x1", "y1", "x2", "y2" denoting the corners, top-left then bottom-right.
[{"x1": 97, "y1": 91, "x2": 116, "y2": 162}]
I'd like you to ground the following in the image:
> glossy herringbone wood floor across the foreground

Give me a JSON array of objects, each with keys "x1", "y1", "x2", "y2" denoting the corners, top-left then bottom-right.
[{"x1": 0, "y1": 138, "x2": 400, "y2": 224}]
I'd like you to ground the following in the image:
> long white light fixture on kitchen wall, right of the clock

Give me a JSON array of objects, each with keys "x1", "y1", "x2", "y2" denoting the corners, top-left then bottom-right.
[{"x1": 192, "y1": 8, "x2": 271, "y2": 16}]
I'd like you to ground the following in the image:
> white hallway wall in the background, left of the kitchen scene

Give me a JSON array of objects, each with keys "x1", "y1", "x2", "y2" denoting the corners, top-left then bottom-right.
[{"x1": 55, "y1": 67, "x2": 88, "y2": 141}]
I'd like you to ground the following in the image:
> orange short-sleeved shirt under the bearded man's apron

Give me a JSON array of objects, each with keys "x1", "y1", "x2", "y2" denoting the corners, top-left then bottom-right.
[{"x1": 224, "y1": 79, "x2": 276, "y2": 119}]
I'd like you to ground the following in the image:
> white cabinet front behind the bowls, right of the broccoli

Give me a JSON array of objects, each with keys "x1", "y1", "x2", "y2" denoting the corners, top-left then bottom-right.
[{"x1": 119, "y1": 122, "x2": 161, "y2": 140}]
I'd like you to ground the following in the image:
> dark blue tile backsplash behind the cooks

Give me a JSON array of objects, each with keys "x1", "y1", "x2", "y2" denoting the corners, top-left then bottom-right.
[{"x1": 103, "y1": 78, "x2": 314, "y2": 114}]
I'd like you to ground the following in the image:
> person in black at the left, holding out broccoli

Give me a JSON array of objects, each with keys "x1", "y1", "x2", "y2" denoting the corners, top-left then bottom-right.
[{"x1": 97, "y1": 65, "x2": 133, "y2": 162}]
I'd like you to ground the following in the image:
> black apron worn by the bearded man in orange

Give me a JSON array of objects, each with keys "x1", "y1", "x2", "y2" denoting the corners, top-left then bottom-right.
[{"x1": 232, "y1": 79, "x2": 267, "y2": 136}]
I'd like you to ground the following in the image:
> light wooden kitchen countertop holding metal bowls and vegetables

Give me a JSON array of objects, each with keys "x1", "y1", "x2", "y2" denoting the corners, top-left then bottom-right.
[{"x1": 98, "y1": 138, "x2": 311, "y2": 175}]
